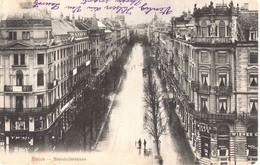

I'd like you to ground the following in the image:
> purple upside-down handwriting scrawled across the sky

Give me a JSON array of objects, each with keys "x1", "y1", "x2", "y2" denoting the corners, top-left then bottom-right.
[{"x1": 33, "y1": 0, "x2": 172, "y2": 15}]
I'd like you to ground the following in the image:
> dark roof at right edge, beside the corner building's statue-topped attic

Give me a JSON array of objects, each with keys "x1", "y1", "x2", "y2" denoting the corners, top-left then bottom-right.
[{"x1": 238, "y1": 11, "x2": 258, "y2": 40}]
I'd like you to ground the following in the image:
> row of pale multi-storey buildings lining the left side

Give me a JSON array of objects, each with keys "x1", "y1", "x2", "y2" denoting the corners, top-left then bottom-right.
[{"x1": 0, "y1": 2, "x2": 127, "y2": 152}]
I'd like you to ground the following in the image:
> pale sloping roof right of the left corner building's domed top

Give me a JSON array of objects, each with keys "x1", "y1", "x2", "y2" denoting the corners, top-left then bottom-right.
[{"x1": 52, "y1": 20, "x2": 79, "y2": 35}]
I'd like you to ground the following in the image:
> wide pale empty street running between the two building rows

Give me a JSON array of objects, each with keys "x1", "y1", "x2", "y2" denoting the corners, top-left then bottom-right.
[{"x1": 91, "y1": 44, "x2": 193, "y2": 165}]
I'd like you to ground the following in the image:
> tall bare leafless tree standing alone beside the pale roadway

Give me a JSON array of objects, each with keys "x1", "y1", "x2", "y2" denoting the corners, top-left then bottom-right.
[{"x1": 144, "y1": 74, "x2": 168, "y2": 158}]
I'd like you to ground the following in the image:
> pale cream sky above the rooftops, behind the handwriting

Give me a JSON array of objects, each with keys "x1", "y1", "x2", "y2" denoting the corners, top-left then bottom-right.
[{"x1": 0, "y1": 0, "x2": 259, "y2": 24}]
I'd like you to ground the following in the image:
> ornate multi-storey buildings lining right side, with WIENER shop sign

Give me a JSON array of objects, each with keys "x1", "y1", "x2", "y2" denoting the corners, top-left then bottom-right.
[{"x1": 151, "y1": 2, "x2": 258, "y2": 165}]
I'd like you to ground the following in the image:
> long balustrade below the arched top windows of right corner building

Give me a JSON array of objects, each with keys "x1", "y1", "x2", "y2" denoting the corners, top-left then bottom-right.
[{"x1": 192, "y1": 37, "x2": 232, "y2": 44}]
